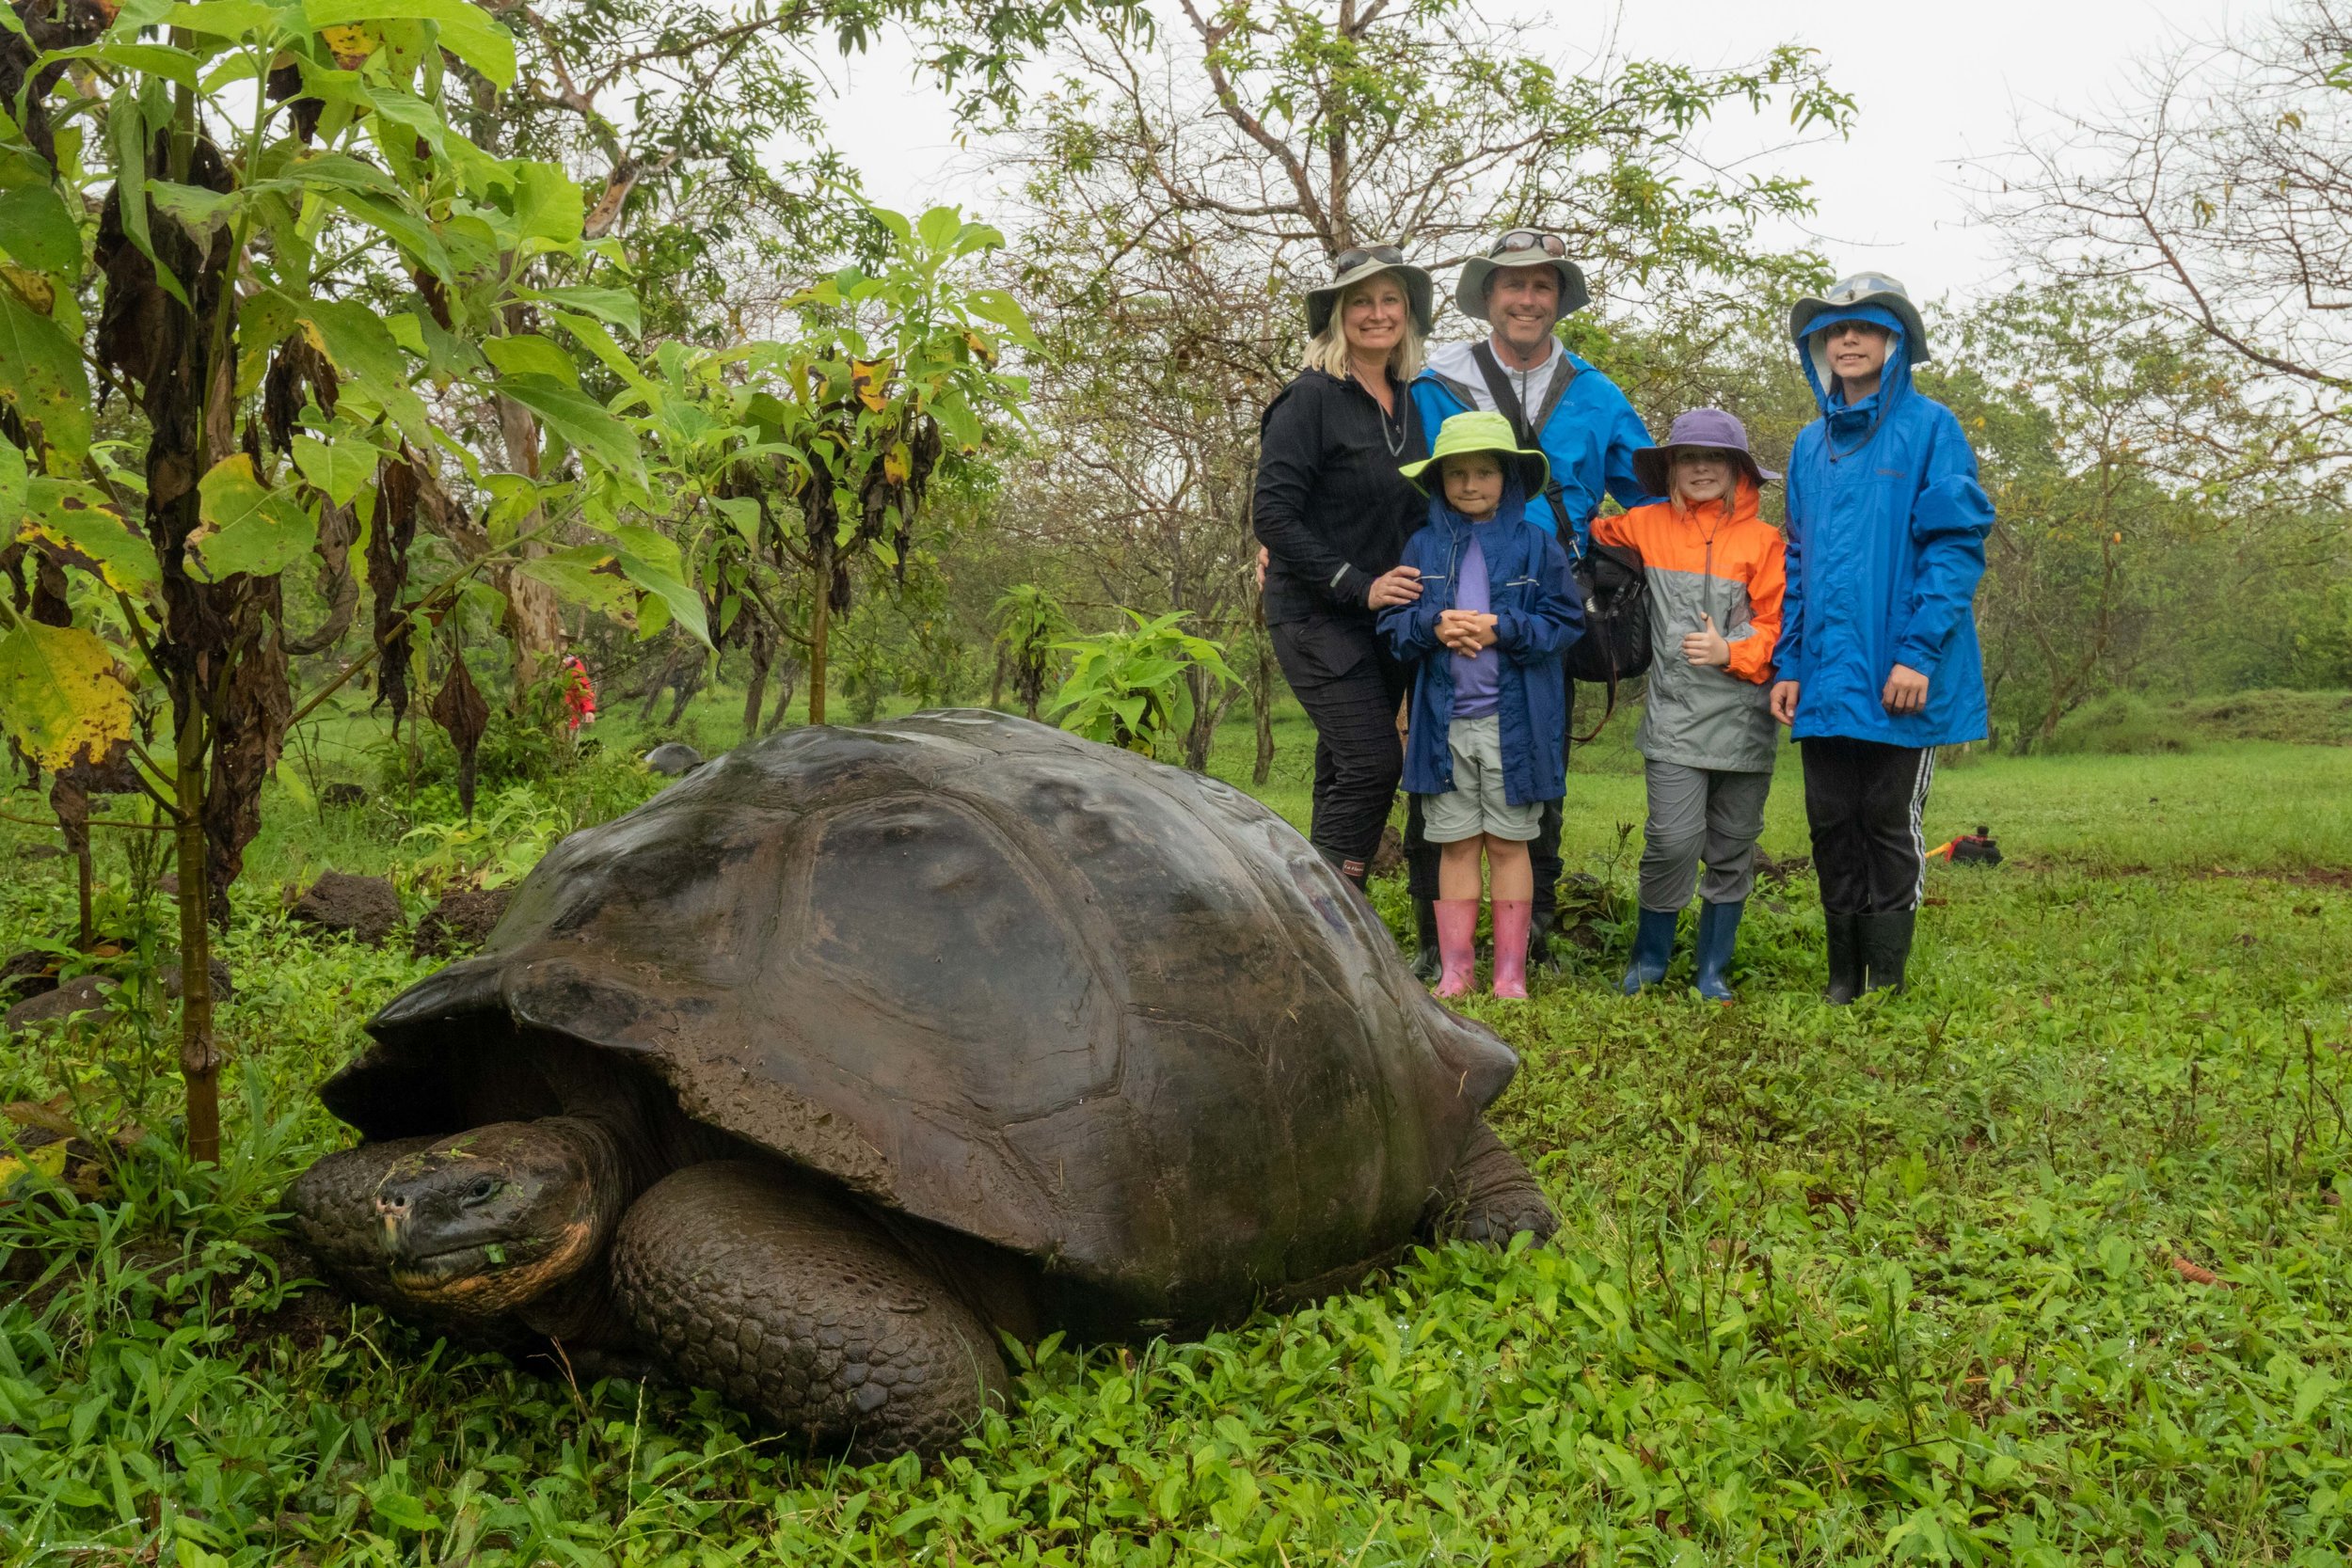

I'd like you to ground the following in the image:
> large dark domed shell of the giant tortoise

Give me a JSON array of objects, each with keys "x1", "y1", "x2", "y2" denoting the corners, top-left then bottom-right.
[{"x1": 323, "y1": 710, "x2": 1518, "y2": 1322}]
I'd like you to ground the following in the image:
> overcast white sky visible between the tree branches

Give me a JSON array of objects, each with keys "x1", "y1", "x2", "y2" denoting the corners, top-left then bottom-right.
[{"x1": 804, "y1": 0, "x2": 2270, "y2": 309}]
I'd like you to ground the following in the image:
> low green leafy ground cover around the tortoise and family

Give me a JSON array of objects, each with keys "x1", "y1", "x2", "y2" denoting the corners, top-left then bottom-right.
[{"x1": 0, "y1": 726, "x2": 2352, "y2": 1568}]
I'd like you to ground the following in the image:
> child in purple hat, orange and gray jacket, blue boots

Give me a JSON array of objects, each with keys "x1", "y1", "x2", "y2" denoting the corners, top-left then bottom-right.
[{"x1": 1593, "y1": 409, "x2": 1788, "y2": 1002}]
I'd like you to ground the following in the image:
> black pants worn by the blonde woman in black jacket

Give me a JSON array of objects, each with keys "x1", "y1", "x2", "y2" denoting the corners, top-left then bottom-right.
[{"x1": 1268, "y1": 616, "x2": 1411, "y2": 881}]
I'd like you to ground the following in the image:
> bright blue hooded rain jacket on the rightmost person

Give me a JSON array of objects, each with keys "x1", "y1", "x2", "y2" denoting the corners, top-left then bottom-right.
[{"x1": 1773, "y1": 306, "x2": 1993, "y2": 748}]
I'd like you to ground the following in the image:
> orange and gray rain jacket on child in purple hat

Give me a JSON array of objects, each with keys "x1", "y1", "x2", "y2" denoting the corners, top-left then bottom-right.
[{"x1": 1593, "y1": 477, "x2": 1788, "y2": 773}]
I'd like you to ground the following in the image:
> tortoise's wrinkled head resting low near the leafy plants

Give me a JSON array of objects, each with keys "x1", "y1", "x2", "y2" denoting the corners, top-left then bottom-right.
[{"x1": 376, "y1": 1117, "x2": 626, "y2": 1317}]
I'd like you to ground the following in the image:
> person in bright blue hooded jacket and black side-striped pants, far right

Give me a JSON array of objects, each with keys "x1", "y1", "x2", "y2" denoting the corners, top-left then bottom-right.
[{"x1": 1772, "y1": 273, "x2": 1993, "y2": 1004}]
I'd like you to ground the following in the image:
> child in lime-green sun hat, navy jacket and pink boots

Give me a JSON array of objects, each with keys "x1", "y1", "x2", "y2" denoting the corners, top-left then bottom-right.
[{"x1": 1381, "y1": 414, "x2": 1585, "y2": 997}]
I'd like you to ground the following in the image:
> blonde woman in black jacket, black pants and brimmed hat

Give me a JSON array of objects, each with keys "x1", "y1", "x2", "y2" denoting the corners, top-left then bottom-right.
[{"x1": 1251, "y1": 245, "x2": 1435, "y2": 921}]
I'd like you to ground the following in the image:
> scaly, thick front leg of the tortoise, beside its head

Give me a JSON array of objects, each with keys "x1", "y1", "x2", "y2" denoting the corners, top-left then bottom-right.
[{"x1": 612, "y1": 1162, "x2": 1007, "y2": 1458}]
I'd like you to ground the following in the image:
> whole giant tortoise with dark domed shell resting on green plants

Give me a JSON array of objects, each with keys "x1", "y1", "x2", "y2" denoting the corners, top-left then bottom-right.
[{"x1": 290, "y1": 712, "x2": 1552, "y2": 1455}]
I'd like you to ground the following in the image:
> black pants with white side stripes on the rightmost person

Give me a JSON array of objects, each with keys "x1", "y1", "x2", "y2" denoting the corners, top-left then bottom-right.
[{"x1": 1797, "y1": 736, "x2": 1936, "y2": 914}]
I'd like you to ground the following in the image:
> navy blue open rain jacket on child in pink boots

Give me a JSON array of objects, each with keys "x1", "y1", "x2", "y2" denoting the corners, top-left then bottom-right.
[{"x1": 1381, "y1": 480, "x2": 1585, "y2": 806}]
